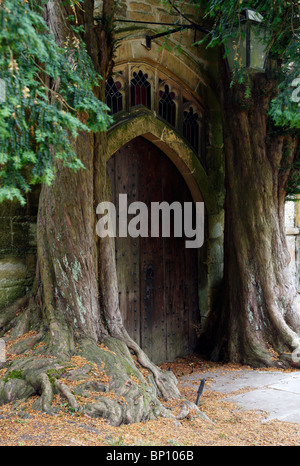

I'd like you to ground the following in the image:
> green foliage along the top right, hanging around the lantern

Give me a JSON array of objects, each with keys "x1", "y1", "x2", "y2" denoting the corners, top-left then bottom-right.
[{"x1": 163, "y1": 0, "x2": 300, "y2": 197}]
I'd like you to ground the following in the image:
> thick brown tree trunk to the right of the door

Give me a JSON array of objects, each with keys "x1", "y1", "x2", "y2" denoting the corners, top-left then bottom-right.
[{"x1": 205, "y1": 59, "x2": 300, "y2": 365}]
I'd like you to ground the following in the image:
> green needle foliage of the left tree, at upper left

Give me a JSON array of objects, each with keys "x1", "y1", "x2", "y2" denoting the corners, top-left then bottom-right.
[{"x1": 0, "y1": 0, "x2": 111, "y2": 204}]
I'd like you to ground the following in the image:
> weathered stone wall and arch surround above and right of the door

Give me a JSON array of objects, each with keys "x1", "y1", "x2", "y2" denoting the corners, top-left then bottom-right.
[{"x1": 107, "y1": 0, "x2": 225, "y2": 326}]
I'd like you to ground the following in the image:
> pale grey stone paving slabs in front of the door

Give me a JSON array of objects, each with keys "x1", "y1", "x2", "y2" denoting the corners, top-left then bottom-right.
[{"x1": 181, "y1": 369, "x2": 300, "y2": 424}]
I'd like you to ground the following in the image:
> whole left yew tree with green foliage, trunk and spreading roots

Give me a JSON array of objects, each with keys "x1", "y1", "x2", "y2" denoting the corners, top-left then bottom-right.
[{"x1": 0, "y1": 0, "x2": 201, "y2": 425}]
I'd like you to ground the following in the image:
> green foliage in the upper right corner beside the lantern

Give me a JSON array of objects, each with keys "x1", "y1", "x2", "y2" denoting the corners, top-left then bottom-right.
[{"x1": 192, "y1": 0, "x2": 300, "y2": 129}]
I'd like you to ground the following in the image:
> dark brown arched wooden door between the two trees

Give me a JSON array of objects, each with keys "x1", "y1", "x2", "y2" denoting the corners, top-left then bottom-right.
[{"x1": 108, "y1": 137, "x2": 200, "y2": 363}]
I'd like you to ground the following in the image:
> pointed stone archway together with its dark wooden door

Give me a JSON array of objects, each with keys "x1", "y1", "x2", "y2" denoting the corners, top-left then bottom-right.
[{"x1": 107, "y1": 110, "x2": 216, "y2": 362}]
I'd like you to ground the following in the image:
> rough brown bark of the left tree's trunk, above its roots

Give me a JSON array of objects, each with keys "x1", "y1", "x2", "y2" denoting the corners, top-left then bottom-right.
[{"x1": 37, "y1": 1, "x2": 104, "y2": 354}]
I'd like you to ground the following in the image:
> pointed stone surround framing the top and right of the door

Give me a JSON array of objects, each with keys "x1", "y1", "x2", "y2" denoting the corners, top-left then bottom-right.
[{"x1": 106, "y1": 108, "x2": 224, "y2": 336}]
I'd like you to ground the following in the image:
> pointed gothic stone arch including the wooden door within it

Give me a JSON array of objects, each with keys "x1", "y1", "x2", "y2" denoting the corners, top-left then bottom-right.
[{"x1": 106, "y1": 108, "x2": 218, "y2": 362}]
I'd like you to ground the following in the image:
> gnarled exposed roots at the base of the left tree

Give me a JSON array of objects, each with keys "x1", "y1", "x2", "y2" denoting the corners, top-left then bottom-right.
[{"x1": 0, "y1": 301, "x2": 205, "y2": 426}]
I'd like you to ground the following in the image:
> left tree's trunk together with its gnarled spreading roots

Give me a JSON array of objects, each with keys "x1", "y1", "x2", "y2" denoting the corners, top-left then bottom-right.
[{"x1": 0, "y1": 0, "x2": 200, "y2": 425}]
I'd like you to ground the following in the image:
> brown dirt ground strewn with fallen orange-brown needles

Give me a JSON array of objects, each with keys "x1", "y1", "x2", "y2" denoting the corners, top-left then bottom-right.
[{"x1": 0, "y1": 355, "x2": 300, "y2": 447}]
